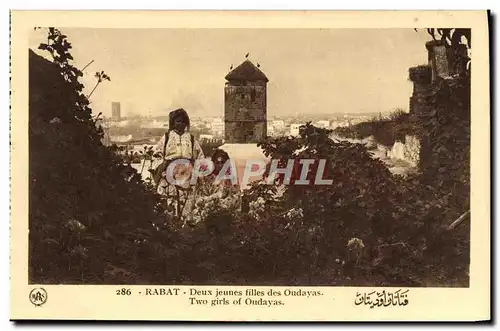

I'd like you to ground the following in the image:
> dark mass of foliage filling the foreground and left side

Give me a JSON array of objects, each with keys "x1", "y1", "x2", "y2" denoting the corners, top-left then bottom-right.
[{"x1": 30, "y1": 29, "x2": 469, "y2": 286}]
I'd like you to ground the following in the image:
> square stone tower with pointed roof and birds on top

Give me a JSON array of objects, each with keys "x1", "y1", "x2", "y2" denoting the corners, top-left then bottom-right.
[{"x1": 224, "y1": 60, "x2": 269, "y2": 144}]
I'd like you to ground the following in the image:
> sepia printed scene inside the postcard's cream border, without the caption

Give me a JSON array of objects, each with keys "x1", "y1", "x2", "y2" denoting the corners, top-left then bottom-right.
[{"x1": 27, "y1": 27, "x2": 472, "y2": 287}]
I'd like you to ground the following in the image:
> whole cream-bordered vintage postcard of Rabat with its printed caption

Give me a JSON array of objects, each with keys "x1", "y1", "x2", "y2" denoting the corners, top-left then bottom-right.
[{"x1": 10, "y1": 11, "x2": 491, "y2": 321}]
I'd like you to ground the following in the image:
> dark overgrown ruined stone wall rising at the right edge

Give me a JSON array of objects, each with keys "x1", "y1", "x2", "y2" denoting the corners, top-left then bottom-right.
[{"x1": 406, "y1": 40, "x2": 470, "y2": 176}]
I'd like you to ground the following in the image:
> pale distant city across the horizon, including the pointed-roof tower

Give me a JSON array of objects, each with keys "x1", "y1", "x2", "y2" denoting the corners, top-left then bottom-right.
[{"x1": 97, "y1": 58, "x2": 406, "y2": 148}]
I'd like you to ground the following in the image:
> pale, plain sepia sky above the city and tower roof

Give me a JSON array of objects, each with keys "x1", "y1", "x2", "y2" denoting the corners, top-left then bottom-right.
[{"x1": 30, "y1": 28, "x2": 430, "y2": 116}]
